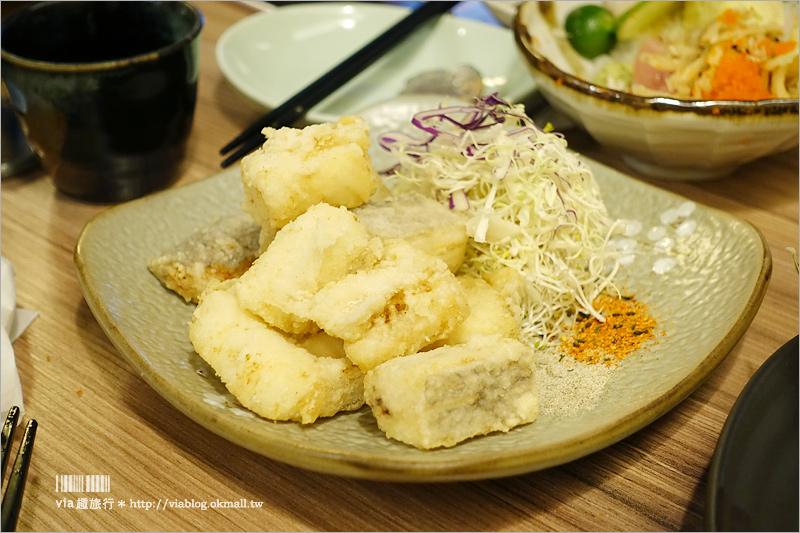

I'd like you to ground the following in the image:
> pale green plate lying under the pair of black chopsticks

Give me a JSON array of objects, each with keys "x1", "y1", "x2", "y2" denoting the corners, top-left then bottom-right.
[{"x1": 216, "y1": 3, "x2": 534, "y2": 122}]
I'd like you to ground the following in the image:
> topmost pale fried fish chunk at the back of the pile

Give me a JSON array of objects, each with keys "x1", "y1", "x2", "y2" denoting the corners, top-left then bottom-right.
[{"x1": 242, "y1": 115, "x2": 378, "y2": 230}]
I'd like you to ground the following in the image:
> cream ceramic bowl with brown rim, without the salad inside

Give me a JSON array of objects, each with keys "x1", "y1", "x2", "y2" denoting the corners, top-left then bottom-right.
[{"x1": 513, "y1": 2, "x2": 798, "y2": 181}]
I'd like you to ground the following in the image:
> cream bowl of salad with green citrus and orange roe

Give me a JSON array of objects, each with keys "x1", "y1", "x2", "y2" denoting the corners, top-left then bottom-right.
[{"x1": 514, "y1": 2, "x2": 800, "y2": 180}]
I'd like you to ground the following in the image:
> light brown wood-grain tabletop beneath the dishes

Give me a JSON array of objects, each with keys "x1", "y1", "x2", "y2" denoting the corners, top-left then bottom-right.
[{"x1": 2, "y1": 2, "x2": 800, "y2": 531}]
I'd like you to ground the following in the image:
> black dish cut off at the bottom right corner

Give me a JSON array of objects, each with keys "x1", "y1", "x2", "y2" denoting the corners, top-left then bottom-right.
[{"x1": 705, "y1": 337, "x2": 800, "y2": 531}]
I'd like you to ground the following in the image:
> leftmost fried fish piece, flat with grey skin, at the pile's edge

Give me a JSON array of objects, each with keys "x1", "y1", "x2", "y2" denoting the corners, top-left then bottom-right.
[{"x1": 148, "y1": 213, "x2": 262, "y2": 302}]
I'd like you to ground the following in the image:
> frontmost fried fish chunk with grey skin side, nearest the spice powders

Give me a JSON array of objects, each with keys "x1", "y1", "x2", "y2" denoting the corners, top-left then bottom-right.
[{"x1": 364, "y1": 335, "x2": 539, "y2": 449}]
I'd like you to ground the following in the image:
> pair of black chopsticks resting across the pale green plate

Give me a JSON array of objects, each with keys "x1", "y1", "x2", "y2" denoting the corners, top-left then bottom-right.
[{"x1": 220, "y1": 1, "x2": 458, "y2": 168}]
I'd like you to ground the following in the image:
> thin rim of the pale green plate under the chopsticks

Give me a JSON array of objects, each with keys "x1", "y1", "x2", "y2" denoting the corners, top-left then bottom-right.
[{"x1": 214, "y1": 1, "x2": 536, "y2": 123}]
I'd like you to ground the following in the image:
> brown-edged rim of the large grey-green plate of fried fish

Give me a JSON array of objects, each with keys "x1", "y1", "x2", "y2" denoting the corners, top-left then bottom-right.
[{"x1": 78, "y1": 160, "x2": 772, "y2": 482}]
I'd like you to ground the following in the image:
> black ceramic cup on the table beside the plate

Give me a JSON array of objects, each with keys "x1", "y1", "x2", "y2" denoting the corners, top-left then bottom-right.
[{"x1": 0, "y1": 1, "x2": 203, "y2": 203}]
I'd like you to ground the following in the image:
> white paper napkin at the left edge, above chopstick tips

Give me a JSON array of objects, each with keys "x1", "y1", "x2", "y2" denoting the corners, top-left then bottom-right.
[{"x1": 0, "y1": 257, "x2": 39, "y2": 423}]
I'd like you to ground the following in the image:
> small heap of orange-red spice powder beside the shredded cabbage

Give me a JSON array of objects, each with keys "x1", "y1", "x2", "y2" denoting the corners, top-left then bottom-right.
[{"x1": 560, "y1": 295, "x2": 658, "y2": 366}]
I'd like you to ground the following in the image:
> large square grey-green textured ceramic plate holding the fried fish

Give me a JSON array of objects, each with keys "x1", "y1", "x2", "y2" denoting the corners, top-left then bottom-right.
[{"x1": 75, "y1": 161, "x2": 772, "y2": 481}]
